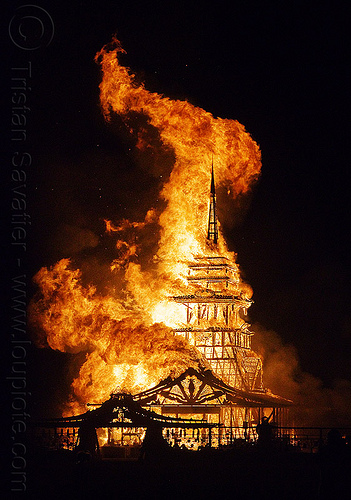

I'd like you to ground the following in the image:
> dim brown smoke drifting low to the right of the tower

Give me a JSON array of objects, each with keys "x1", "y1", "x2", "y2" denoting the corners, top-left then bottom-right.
[{"x1": 252, "y1": 324, "x2": 351, "y2": 427}]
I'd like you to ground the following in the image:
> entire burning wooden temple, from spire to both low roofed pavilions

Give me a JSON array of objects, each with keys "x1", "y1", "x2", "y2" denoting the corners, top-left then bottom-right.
[{"x1": 33, "y1": 166, "x2": 292, "y2": 453}]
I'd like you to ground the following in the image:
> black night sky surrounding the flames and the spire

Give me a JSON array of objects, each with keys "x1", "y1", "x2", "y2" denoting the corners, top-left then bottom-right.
[{"x1": 5, "y1": 0, "x2": 351, "y2": 418}]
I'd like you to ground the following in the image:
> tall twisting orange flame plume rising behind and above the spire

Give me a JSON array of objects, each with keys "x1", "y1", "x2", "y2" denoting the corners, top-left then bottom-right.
[{"x1": 96, "y1": 39, "x2": 261, "y2": 264}]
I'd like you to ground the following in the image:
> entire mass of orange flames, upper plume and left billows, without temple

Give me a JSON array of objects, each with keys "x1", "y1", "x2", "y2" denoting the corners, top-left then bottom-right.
[{"x1": 30, "y1": 40, "x2": 261, "y2": 411}]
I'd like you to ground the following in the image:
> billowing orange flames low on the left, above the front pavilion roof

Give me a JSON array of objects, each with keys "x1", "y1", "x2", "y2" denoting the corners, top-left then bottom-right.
[{"x1": 30, "y1": 259, "x2": 204, "y2": 411}]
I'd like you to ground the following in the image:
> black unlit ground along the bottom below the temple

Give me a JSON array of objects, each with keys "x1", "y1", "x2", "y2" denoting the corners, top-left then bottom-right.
[{"x1": 23, "y1": 449, "x2": 347, "y2": 500}]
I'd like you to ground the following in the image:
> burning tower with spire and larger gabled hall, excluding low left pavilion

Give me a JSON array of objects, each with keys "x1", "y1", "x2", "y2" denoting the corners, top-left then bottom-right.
[{"x1": 129, "y1": 166, "x2": 291, "y2": 445}]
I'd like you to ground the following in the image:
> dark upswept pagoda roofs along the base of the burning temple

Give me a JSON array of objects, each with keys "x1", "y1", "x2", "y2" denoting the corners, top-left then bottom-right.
[{"x1": 32, "y1": 367, "x2": 293, "y2": 428}]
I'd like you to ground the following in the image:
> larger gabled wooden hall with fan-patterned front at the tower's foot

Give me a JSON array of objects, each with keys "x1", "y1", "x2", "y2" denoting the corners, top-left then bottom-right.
[{"x1": 133, "y1": 368, "x2": 291, "y2": 447}]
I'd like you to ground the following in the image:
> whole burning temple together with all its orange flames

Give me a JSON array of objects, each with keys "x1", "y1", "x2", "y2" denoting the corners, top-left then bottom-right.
[{"x1": 30, "y1": 40, "x2": 292, "y2": 453}]
